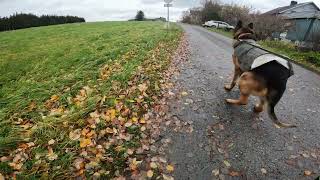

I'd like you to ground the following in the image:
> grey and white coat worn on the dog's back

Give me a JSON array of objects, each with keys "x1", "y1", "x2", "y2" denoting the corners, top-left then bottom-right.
[{"x1": 234, "y1": 39, "x2": 293, "y2": 75}]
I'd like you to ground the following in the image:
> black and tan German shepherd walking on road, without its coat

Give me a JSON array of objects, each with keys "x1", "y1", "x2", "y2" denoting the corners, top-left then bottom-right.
[{"x1": 224, "y1": 21, "x2": 296, "y2": 128}]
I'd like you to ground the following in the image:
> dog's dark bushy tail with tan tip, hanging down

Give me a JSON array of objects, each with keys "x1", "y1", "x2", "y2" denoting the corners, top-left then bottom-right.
[{"x1": 267, "y1": 87, "x2": 297, "y2": 128}]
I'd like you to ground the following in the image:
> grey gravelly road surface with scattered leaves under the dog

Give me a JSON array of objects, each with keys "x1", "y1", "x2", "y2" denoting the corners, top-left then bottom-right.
[{"x1": 164, "y1": 25, "x2": 320, "y2": 180}]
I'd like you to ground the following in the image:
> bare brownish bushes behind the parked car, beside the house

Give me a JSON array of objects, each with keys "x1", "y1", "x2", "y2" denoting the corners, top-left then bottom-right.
[{"x1": 182, "y1": 0, "x2": 286, "y2": 39}]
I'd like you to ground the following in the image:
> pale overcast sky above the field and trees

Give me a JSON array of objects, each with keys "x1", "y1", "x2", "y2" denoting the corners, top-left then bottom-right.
[{"x1": 0, "y1": 0, "x2": 320, "y2": 21}]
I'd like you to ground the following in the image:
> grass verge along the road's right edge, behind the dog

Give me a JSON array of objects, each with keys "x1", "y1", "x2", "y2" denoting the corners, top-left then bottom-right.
[{"x1": 208, "y1": 28, "x2": 320, "y2": 72}]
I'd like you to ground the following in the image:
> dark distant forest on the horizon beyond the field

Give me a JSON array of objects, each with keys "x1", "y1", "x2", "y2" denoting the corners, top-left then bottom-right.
[{"x1": 0, "y1": 13, "x2": 85, "y2": 31}]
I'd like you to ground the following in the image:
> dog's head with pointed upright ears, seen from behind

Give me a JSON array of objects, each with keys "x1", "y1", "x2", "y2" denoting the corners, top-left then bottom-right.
[{"x1": 233, "y1": 21, "x2": 256, "y2": 40}]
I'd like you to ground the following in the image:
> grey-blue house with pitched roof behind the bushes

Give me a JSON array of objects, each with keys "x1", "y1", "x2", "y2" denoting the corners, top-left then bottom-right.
[{"x1": 264, "y1": 1, "x2": 320, "y2": 43}]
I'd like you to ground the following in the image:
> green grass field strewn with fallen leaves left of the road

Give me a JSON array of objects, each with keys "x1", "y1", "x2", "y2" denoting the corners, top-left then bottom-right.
[{"x1": 0, "y1": 22, "x2": 182, "y2": 179}]
